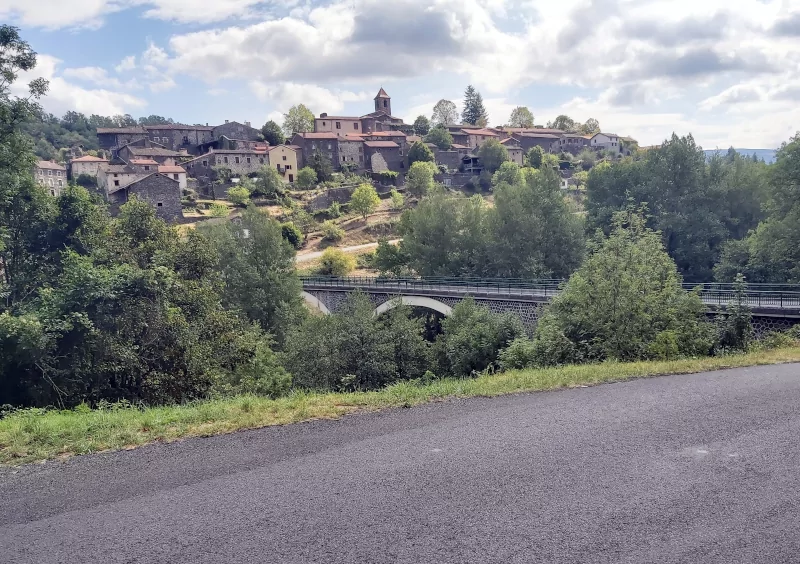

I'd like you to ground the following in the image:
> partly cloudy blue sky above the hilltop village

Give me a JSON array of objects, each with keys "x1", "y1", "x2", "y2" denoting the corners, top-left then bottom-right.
[{"x1": 0, "y1": 0, "x2": 800, "y2": 149}]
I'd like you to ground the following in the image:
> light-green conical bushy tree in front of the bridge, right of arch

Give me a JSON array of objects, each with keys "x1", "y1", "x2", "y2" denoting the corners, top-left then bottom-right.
[{"x1": 534, "y1": 211, "x2": 713, "y2": 364}]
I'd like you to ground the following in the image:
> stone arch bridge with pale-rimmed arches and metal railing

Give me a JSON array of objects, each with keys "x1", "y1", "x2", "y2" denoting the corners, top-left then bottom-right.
[{"x1": 301, "y1": 277, "x2": 800, "y2": 333}]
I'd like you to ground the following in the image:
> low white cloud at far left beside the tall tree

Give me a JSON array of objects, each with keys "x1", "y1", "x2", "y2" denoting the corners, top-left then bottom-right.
[{"x1": 13, "y1": 55, "x2": 146, "y2": 116}]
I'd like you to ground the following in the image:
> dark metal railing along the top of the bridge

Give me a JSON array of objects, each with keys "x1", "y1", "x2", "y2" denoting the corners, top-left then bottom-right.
[{"x1": 301, "y1": 276, "x2": 800, "y2": 309}]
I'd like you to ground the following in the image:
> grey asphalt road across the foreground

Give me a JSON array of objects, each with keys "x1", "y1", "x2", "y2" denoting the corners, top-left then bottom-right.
[{"x1": 0, "y1": 365, "x2": 800, "y2": 564}]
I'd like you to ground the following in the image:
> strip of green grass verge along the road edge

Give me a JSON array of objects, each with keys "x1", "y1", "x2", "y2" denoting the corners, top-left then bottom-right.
[{"x1": 0, "y1": 347, "x2": 800, "y2": 465}]
